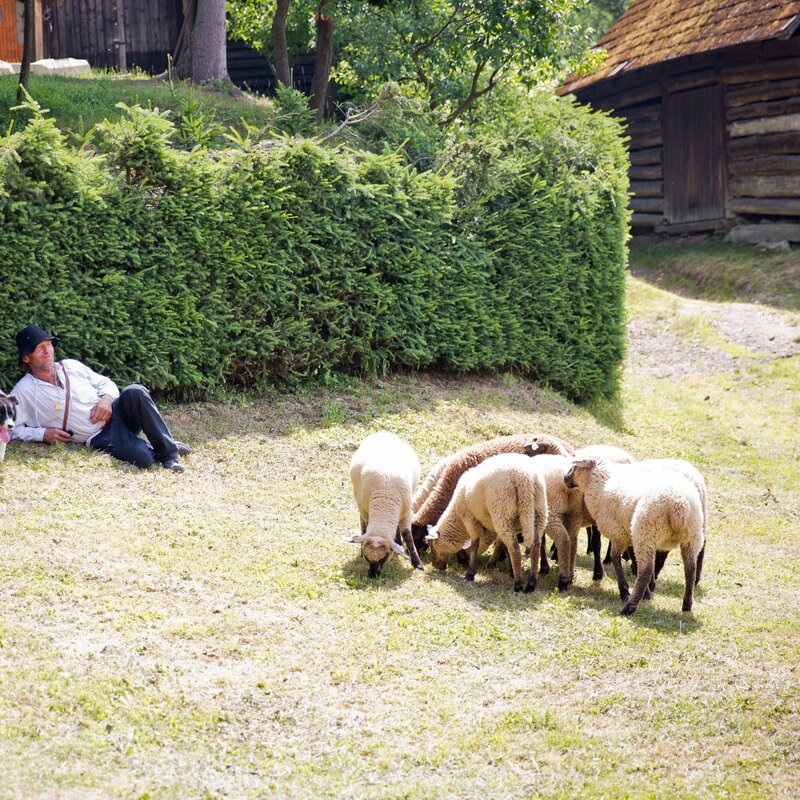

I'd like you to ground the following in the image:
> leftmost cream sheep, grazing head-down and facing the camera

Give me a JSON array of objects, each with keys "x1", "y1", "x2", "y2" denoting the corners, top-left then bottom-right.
[{"x1": 350, "y1": 431, "x2": 423, "y2": 578}]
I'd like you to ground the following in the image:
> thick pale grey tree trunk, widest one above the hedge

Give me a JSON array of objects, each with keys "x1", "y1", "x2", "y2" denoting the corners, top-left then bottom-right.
[{"x1": 175, "y1": 0, "x2": 228, "y2": 83}]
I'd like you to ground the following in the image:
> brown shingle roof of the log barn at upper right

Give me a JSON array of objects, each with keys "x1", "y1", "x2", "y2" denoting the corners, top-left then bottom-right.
[{"x1": 560, "y1": 0, "x2": 800, "y2": 93}]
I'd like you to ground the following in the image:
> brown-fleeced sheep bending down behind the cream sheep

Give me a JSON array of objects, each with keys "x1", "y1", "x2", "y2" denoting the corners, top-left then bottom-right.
[{"x1": 411, "y1": 433, "x2": 575, "y2": 547}]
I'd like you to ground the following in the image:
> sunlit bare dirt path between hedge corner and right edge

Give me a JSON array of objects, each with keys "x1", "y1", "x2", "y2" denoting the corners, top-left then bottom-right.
[{"x1": 627, "y1": 298, "x2": 800, "y2": 378}]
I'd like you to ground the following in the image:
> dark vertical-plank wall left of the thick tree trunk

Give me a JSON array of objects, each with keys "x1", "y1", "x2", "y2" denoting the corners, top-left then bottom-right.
[{"x1": 43, "y1": 0, "x2": 183, "y2": 72}]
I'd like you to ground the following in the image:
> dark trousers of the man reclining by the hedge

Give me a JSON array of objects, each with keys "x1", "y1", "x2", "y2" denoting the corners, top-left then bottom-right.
[{"x1": 91, "y1": 383, "x2": 178, "y2": 467}]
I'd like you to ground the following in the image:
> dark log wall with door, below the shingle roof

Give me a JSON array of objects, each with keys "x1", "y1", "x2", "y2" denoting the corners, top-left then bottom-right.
[{"x1": 577, "y1": 35, "x2": 800, "y2": 232}]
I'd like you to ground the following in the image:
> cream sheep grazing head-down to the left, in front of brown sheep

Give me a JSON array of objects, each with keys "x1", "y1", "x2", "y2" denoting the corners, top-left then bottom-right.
[{"x1": 426, "y1": 453, "x2": 548, "y2": 592}]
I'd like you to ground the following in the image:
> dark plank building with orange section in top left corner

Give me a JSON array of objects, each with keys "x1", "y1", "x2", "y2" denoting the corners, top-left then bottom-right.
[{"x1": 0, "y1": 0, "x2": 183, "y2": 72}]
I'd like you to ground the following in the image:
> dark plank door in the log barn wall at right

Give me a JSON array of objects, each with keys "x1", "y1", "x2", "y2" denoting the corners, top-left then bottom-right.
[{"x1": 663, "y1": 84, "x2": 726, "y2": 225}]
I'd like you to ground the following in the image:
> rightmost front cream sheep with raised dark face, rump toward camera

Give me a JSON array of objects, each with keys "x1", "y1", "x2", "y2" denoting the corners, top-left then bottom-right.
[{"x1": 564, "y1": 459, "x2": 703, "y2": 615}]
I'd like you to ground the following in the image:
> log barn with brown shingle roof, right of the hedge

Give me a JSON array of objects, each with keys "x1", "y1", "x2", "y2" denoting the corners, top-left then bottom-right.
[{"x1": 559, "y1": 0, "x2": 800, "y2": 241}]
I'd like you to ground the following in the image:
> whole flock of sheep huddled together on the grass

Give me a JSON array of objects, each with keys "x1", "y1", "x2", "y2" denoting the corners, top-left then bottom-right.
[{"x1": 350, "y1": 431, "x2": 707, "y2": 615}]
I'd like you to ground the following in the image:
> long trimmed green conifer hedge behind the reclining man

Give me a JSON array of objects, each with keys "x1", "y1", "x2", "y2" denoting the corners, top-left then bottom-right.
[{"x1": 0, "y1": 97, "x2": 627, "y2": 399}]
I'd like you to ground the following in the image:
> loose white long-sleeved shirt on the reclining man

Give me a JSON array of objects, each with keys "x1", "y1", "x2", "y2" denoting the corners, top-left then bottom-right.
[{"x1": 11, "y1": 358, "x2": 119, "y2": 444}]
